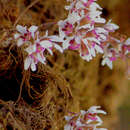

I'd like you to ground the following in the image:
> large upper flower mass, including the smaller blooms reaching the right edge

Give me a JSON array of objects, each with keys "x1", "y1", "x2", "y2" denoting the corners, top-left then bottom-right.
[{"x1": 58, "y1": 0, "x2": 130, "y2": 69}]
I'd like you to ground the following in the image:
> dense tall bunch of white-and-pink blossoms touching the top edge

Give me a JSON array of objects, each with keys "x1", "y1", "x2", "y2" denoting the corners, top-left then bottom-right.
[{"x1": 58, "y1": 0, "x2": 108, "y2": 61}]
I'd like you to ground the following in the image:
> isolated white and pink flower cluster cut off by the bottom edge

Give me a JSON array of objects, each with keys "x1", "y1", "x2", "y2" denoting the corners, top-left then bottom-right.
[{"x1": 64, "y1": 106, "x2": 107, "y2": 130}]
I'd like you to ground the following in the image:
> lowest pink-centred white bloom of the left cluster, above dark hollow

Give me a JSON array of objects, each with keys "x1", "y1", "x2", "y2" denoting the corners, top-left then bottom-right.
[{"x1": 24, "y1": 40, "x2": 53, "y2": 71}]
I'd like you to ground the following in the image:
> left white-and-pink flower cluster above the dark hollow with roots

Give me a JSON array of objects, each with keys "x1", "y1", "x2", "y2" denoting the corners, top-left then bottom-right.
[{"x1": 14, "y1": 25, "x2": 63, "y2": 71}]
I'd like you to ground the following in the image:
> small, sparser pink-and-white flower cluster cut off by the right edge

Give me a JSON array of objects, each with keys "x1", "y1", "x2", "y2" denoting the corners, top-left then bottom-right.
[{"x1": 102, "y1": 37, "x2": 130, "y2": 71}]
